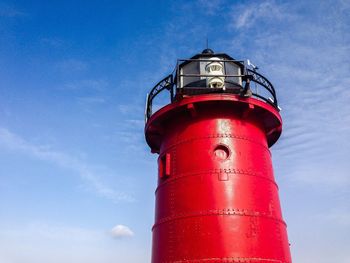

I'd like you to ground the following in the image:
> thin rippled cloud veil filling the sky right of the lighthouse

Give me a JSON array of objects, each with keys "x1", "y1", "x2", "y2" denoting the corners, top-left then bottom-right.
[{"x1": 223, "y1": 0, "x2": 350, "y2": 263}]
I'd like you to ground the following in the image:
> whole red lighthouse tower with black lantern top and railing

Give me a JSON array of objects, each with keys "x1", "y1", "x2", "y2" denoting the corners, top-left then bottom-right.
[{"x1": 145, "y1": 49, "x2": 291, "y2": 263}]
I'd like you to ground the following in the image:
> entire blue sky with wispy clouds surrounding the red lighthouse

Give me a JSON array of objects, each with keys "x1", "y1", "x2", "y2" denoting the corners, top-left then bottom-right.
[{"x1": 0, "y1": 0, "x2": 350, "y2": 263}]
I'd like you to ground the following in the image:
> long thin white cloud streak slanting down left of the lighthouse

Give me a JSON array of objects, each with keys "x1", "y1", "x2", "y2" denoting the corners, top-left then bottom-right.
[{"x1": 0, "y1": 128, "x2": 134, "y2": 203}]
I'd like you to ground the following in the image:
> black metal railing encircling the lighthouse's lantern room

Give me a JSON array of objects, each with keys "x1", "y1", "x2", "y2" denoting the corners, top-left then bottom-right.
[{"x1": 145, "y1": 59, "x2": 280, "y2": 122}]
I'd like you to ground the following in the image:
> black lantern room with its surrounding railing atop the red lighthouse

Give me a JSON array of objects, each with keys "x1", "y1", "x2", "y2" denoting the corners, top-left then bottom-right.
[{"x1": 145, "y1": 48, "x2": 280, "y2": 120}]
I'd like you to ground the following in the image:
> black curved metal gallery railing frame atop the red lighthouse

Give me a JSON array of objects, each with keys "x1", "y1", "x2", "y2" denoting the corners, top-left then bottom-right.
[{"x1": 145, "y1": 59, "x2": 280, "y2": 121}]
